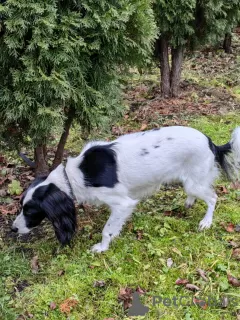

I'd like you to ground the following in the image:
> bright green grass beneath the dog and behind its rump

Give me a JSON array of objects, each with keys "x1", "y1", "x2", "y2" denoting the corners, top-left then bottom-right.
[{"x1": 0, "y1": 114, "x2": 240, "y2": 320}]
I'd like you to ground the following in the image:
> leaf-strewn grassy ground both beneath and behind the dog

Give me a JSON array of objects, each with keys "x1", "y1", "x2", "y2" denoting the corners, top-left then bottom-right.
[{"x1": 0, "y1": 42, "x2": 240, "y2": 320}]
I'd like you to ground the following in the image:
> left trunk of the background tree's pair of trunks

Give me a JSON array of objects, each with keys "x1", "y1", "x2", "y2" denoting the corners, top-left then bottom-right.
[{"x1": 158, "y1": 36, "x2": 170, "y2": 98}]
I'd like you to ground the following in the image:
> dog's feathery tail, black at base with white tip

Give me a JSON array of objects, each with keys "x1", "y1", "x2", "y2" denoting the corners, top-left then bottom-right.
[{"x1": 209, "y1": 127, "x2": 240, "y2": 182}]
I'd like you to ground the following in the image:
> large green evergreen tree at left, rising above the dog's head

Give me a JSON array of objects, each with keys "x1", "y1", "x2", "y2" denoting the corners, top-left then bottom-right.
[{"x1": 0, "y1": 0, "x2": 156, "y2": 174}]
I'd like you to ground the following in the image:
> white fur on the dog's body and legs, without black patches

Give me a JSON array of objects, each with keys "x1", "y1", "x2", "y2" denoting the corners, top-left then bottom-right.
[{"x1": 66, "y1": 127, "x2": 219, "y2": 252}]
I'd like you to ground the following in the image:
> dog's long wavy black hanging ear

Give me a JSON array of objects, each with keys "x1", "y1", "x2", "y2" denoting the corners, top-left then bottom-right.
[{"x1": 38, "y1": 183, "x2": 77, "y2": 245}]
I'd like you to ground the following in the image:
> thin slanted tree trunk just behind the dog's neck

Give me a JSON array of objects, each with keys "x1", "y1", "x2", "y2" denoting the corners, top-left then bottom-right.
[{"x1": 51, "y1": 108, "x2": 75, "y2": 170}]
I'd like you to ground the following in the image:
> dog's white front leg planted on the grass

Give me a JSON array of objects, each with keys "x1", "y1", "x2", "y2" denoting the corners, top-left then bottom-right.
[{"x1": 92, "y1": 198, "x2": 138, "y2": 252}]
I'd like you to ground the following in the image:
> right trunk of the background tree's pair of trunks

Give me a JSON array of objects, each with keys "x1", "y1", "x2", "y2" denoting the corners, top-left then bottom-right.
[{"x1": 170, "y1": 46, "x2": 183, "y2": 97}]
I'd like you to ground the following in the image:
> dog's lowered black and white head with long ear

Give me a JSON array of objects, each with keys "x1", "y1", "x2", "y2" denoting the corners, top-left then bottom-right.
[{"x1": 12, "y1": 166, "x2": 76, "y2": 245}]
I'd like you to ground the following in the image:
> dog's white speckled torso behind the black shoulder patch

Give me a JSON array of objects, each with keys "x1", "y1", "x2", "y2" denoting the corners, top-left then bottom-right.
[{"x1": 114, "y1": 126, "x2": 217, "y2": 193}]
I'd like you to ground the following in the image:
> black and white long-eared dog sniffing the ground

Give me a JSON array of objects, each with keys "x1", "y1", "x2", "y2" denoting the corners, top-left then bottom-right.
[{"x1": 12, "y1": 126, "x2": 240, "y2": 252}]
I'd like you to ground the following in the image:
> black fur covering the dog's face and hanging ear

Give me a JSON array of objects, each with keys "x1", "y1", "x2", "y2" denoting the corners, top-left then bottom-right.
[{"x1": 23, "y1": 183, "x2": 77, "y2": 245}]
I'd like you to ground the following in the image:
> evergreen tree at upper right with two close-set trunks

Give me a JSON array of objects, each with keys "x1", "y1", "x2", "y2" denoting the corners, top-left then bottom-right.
[{"x1": 153, "y1": 0, "x2": 240, "y2": 97}]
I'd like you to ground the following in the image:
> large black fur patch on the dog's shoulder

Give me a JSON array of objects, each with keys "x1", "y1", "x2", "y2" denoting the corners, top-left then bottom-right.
[{"x1": 79, "y1": 144, "x2": 118, "y2": 188}]
